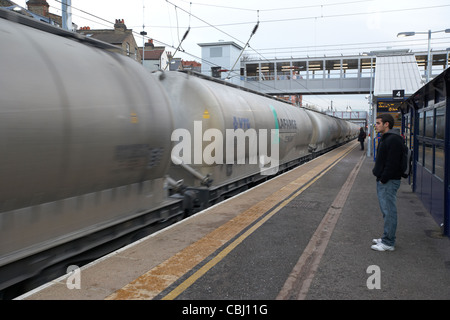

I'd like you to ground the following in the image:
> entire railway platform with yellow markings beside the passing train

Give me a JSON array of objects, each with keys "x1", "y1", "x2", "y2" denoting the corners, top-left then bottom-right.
[{"x1": 17, "y1": 141, "x2": 450, "y2": 302}]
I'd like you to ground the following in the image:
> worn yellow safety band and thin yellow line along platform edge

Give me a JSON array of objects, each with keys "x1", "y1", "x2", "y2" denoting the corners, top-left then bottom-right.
[{"x1": 106, "y1": 143, "x2": 359, "y2": 300}]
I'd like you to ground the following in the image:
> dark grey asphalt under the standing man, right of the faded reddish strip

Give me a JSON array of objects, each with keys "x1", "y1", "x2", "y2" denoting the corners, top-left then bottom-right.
[{"x1": 307, "y1": 150, "x2": 450, "y2": 300}]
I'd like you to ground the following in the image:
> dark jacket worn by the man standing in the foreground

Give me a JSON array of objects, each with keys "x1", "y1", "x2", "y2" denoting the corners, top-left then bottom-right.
[{"x1": 372, "y1": 131, "x2": 403, "y2": 183}]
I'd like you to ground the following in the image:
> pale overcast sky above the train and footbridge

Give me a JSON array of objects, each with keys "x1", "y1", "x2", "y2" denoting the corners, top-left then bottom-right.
[{"x1": 11, "y1": 0, "x2": 450, "y2": 111}]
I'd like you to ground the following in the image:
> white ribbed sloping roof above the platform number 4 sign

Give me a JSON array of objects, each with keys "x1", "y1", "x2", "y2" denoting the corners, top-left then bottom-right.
[{"x1": 374, "y1": 54, "x2": 422, "y2": 97}]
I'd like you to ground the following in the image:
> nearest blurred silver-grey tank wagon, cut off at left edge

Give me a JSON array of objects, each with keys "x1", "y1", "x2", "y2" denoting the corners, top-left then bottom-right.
[{"x1": 0, "y1": 12, "x2": 173, "y2": 289}]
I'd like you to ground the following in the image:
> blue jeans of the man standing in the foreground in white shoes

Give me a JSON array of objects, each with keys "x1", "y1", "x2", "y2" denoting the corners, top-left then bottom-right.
[{"x1": 377, "y1": 180, "x2": 400, "y2": 246}]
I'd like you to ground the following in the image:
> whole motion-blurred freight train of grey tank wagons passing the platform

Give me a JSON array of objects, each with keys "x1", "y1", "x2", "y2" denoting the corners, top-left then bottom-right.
[{"x1": 0, "y1": 10, "x2": 359, "y2": 298}]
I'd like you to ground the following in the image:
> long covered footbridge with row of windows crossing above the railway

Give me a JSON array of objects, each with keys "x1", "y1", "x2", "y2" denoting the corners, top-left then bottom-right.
[{"x1": 241, "y1": 49, "x2": 449, "y2": 95}]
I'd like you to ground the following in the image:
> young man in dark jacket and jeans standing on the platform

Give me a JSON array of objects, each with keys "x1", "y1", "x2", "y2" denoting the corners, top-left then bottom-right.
[{"x1": 371, "y1": 114, "x2": 403, "y2": 251}]
